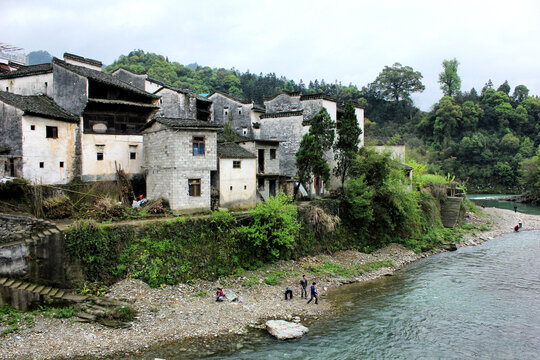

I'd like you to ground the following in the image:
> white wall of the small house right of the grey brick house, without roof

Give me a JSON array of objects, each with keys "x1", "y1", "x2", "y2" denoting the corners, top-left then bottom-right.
[{"x1": 219, "y1": 158, "x2": 257, "y2": 208}]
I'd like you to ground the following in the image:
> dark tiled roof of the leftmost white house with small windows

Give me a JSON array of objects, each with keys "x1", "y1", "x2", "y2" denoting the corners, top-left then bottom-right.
[{"x1": 0, "y1": 91, "x2": 79, "y2": 122}]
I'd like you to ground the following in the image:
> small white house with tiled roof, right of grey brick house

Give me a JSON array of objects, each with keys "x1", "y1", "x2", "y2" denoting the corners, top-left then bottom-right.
[{"x1": 217, "y1": 142, "x2": 257, "y2": 209}]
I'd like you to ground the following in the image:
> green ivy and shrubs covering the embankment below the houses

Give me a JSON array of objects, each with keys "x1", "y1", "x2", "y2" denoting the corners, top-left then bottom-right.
[{"x1": 66, "y1": 149, "x2": 472, "y2": 287}]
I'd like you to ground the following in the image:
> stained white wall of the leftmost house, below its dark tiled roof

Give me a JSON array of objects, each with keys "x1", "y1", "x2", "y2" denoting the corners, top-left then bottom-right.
[{"x1": 22, "y1": 115, "x2": 77, "y2": 184}]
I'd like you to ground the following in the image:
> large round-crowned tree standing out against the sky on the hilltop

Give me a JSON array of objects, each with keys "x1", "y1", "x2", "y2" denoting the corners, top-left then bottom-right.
[{"x1": 373, "y1": 63, "x2": 425, "y2": 103}]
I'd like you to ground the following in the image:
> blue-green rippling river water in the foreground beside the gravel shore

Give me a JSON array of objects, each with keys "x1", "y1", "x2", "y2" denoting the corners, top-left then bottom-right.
[{"x1": 132, "y1": 231, "x2": 540, "y2": 360}]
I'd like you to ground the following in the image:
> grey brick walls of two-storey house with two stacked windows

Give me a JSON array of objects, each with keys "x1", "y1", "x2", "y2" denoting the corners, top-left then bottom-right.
[{"x1": 144, "y1": 123, "x2": 217, "y2": 210}]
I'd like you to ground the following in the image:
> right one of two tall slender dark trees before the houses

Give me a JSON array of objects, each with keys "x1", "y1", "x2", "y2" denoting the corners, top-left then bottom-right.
[{"x1": 334, "y1": 101, "x2": 362, "y2": 187}]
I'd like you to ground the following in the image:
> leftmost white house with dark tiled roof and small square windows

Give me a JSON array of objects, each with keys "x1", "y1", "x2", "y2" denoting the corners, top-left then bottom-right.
[{"x1": 0, "y1": 91, "x2": 79, "y2": 184}]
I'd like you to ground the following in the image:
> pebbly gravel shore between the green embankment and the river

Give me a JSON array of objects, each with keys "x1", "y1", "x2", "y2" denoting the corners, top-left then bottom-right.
[{"x1": 0, "y1": 208, "x2": 540, "y2": 359}]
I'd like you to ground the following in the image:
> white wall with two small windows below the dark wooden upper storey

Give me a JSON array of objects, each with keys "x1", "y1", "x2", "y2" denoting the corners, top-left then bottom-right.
[{"x1": 82, "y1": 134, "x2": 144, "y2": 181}]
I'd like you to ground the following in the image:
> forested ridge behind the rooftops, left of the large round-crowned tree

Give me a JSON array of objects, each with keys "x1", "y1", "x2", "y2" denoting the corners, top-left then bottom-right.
[{"x1": 104, "y1": 50, "x2": 361, "y2": 104}]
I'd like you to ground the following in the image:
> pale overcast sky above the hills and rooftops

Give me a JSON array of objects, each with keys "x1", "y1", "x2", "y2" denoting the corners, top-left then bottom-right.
[{"x1": 0, "y1": 0, "x2": 540, "y2": 110}]
